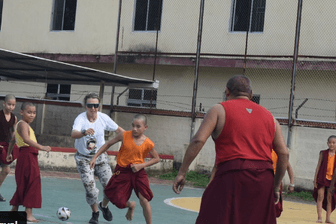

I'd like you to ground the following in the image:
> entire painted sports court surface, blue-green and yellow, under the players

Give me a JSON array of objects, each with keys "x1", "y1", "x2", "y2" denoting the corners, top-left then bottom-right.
[{"x1": 0, "y1": 172, "x2": 336, "y2": 224}]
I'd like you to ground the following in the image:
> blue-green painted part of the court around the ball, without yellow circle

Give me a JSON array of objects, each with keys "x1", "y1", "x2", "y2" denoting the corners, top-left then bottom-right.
[{"x1": 0, "y1": 175, "x2": 203, "y2": 224}]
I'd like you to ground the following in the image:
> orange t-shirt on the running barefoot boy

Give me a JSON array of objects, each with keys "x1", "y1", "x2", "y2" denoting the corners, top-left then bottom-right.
[{"x1": 117, "y1": 131, "x2": 154, "y2": 167}]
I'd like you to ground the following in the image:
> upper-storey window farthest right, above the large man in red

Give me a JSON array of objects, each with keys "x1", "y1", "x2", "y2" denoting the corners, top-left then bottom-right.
[{"x1": 231, "y1": 0, "x2": 266, "y2": 32}]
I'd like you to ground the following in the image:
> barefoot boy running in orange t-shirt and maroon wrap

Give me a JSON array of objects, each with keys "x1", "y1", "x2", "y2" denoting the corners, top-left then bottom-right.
[{"x1": 90, "y1": 114, "x2": 160, "y2": 224}]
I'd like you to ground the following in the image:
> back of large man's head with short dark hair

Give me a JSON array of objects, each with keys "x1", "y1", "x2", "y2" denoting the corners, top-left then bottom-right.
[{"x1": 226, "y1": 75, "x2": 252, "y2": 96}]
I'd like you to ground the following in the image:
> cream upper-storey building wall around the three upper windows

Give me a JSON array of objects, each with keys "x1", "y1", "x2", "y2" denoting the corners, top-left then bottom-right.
[{"x1": 0, "y1": 0, "x2": 336, "y2": 56}]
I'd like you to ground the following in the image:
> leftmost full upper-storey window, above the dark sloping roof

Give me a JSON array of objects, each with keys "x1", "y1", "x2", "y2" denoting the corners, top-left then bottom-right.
[{"x1": 52, "y1": 0, "x2": 77, "y2": 30}]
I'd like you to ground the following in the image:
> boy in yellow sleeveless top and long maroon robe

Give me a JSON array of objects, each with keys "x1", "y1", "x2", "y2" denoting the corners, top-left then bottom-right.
[{"x1": 10, "y1": 102, "x2": 51, "y2": 222}]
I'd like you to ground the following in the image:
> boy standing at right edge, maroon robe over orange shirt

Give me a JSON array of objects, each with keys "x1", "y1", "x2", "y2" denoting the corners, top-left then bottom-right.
[{"x1": 313, "y1": 135, "x2": 336, "y2": 223}]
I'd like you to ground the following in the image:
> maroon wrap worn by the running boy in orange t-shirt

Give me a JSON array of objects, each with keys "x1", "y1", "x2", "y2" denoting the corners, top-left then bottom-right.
[{"x1": 104, "y1": 165, "x2": 153, "y2": 208}]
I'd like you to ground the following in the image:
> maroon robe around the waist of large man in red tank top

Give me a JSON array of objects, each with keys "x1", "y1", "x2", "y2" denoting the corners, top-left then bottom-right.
[{"x1": 196, "y1": 159, "x2": 276, "y2": 224}]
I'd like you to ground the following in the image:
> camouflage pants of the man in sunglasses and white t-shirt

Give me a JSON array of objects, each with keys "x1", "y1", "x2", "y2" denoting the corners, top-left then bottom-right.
[{"x1": 75, "y1": 152, "x2": 112, "y2": 205}]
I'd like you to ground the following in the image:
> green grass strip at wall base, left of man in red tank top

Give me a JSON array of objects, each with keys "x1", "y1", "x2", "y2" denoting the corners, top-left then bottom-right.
[{"x1": 159, "y1": 169, "x2": 210, "y2": 188}]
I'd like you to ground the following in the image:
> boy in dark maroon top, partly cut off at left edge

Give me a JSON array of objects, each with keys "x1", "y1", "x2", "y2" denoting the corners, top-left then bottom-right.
[{"x1": 0, "y1": 94, "x2": 18, "y2": 201}]
